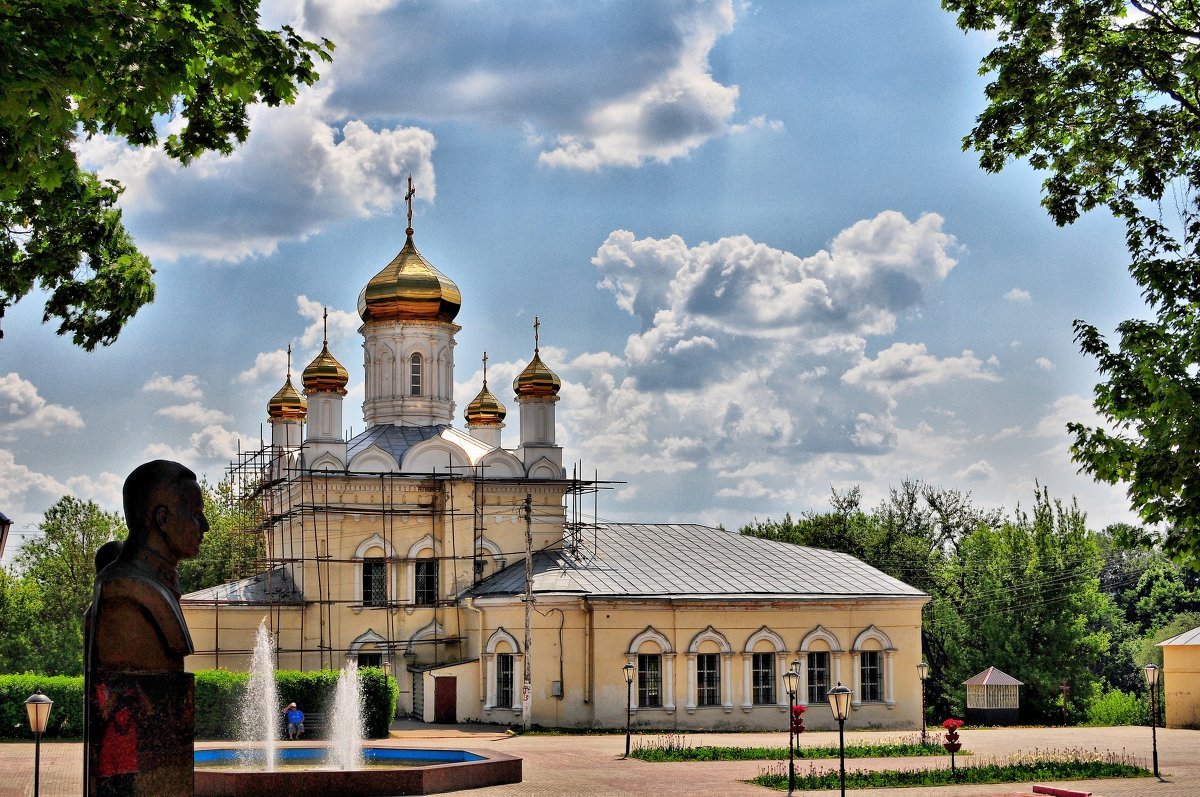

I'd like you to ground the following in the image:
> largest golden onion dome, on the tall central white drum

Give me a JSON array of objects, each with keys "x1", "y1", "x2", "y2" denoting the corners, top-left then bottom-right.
[{"x1": 359, "y1": 227, "x2": 462, "y2": 322}]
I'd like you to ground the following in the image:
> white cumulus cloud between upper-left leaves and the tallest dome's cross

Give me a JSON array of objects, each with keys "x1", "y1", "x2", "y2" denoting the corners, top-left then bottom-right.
[{"x1": 77, "y1": 88, "x2": 436, "y2": 262}]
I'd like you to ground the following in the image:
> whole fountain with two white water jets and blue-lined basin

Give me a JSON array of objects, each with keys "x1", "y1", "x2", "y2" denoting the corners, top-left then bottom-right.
[{"x1": 194, "y1": 617, "x2": 521, "y2": 797}]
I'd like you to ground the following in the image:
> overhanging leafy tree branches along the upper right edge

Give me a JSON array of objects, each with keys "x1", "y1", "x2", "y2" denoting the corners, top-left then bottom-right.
[{"x1": 942, "y1": 0, "x2": 1200, "y2": 568}]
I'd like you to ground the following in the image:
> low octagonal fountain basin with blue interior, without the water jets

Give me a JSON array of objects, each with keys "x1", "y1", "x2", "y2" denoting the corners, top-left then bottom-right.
[{"x1": 194, "y1": 745, "x2": 521, "y2": 797}]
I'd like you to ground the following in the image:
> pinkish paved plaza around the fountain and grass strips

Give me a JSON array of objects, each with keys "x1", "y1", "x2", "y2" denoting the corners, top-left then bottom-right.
[{"x1": 0, "y1": 723, "x2": 1200, "y2": 797}]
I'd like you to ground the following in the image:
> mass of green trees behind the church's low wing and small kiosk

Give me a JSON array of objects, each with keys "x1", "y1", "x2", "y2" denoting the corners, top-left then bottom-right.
[{"x1": 742, "y1": 480, "x2": 1152, "y2": 721}]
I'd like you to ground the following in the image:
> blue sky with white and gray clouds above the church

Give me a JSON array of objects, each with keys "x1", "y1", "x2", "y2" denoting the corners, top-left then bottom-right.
[{"x1": 0, "y1": 0, "x2": 1146, "y2": 558}]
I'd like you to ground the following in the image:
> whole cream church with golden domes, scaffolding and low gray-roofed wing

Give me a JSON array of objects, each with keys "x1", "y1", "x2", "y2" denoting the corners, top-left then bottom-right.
[{"x1": 181, "y1": 191, "x2": 929, "y2": 730}]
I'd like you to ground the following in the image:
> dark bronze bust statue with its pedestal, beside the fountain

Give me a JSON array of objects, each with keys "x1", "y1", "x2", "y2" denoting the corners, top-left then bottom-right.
[{"x1": 84, "y1": 460, "x2": 209, "y2": 797}]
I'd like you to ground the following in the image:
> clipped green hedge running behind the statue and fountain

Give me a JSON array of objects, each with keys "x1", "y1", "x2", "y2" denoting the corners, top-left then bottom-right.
[{"x1": 0, "y1": 667, "x2": 400, "y2": 739}]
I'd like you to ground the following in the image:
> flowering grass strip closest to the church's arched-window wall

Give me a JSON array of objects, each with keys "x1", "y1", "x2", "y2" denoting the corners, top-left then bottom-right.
[{"x1": 630, "y1": 733, "x2": 964, "y2": 762}]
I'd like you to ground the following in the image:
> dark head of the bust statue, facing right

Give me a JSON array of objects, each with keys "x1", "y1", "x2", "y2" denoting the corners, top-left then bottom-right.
[{"x1": 121, "y1": 460, "x2": 209, "y2": 562}]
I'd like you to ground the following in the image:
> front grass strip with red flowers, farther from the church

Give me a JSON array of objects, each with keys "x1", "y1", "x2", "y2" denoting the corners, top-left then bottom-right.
[{"x1": 750, "y1": 749, "x2": 1151, "y2": 790}]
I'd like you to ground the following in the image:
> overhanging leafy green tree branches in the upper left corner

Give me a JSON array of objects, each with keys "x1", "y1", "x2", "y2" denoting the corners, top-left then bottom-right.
[{"x1": 0, "y1": 0, "x2": 332, "y2": 350}]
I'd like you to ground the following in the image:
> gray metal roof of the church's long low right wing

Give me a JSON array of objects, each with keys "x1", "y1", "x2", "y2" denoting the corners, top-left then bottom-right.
[{"x1": 472, "y1": 523, "x2": 925, "y2": 598}]
